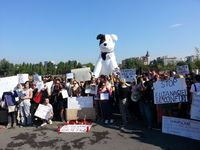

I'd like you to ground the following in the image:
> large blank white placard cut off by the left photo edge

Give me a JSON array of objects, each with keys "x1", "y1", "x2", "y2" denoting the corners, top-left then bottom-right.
[{"x1": 0, "y1": 76, "x2": 18, "y2": 98}]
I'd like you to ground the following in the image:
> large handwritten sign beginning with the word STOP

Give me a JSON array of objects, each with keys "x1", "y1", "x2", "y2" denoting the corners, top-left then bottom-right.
[{"x1": 153, "y1": 78, "x2": 187, "y2": 104}]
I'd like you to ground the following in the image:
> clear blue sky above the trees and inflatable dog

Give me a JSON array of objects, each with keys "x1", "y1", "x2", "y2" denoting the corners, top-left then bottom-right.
[{"x1": 0, "y1": 0, "x2": 200, "y2": 63}]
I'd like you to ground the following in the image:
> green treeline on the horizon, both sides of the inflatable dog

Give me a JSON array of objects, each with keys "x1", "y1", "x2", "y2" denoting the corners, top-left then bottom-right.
[{"x1": 0, "y1": 56, "x2": 200, "y2": 77}]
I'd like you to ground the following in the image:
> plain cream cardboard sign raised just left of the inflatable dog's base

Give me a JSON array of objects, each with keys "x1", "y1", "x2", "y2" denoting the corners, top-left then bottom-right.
[{"x1": 71, "y1": 67, "x2": 91, "y2": 82}]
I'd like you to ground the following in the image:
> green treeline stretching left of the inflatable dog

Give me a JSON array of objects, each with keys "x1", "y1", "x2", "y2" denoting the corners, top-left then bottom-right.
[{"x1": 0, "y1": 59, "x2": 94, "y2": 77}]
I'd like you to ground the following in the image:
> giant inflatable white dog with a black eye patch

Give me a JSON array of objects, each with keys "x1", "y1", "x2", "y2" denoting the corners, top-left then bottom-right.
[{"x1": 93, "y1": 34, "x2": 119, "y2": 78}]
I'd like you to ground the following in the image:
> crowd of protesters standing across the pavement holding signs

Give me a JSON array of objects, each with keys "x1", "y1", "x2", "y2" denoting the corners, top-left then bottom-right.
[{"x1": 1, "y1": 71, "x2": 200, "y2": 129}]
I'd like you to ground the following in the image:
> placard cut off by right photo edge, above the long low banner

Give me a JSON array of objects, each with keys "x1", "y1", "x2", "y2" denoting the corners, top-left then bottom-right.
[{"x1": 190, "y1": 92, "x2": 200, "y2": 120}]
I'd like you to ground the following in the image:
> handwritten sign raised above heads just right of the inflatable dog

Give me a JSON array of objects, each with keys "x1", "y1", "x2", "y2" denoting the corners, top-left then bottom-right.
[{"x1": 120, "y1": 69, "x2": 136, "y2": 82}]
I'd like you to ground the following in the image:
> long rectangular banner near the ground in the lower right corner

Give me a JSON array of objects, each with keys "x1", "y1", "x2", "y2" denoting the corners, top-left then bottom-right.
[{"x1": 162, "y1": 116, "x2": 200, "y2": 140}]
